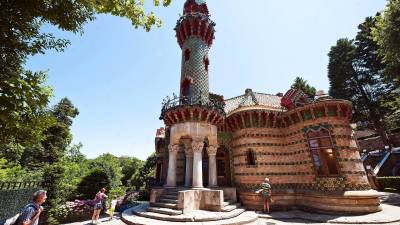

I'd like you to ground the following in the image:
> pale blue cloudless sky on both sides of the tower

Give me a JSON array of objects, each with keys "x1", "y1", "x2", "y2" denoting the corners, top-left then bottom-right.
[{"x1": 27, "y1": 0, "x2": 386, "y2": 159}]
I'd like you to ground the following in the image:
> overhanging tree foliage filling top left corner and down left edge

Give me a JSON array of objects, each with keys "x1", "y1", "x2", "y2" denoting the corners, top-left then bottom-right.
[{"x1": 0, "y1": 0, "x2": 171, "y2": 152}]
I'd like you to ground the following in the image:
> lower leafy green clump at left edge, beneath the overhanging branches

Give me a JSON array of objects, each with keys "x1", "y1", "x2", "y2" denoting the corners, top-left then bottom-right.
[{"x1": 0, "y1": 71, "x2": 55, "y2": 155}]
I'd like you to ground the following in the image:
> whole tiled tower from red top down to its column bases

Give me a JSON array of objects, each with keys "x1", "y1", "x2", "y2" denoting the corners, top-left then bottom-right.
[{"x1": 160, "y1": 0, "x2": 225, "y2": 188}]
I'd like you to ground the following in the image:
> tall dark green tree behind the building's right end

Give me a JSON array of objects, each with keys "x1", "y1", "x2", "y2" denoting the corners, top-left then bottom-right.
[{"x1": 328, "y1": 17, "x2": 393, "y2": 144}]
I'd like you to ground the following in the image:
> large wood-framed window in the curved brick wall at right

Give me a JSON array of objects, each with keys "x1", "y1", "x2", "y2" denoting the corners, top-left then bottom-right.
[{"x1": 306, "y1": 127, "x2": 339, "y2": 176}]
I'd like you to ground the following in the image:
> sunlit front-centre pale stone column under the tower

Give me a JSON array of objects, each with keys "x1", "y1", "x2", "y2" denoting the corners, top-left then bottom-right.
[{"x1": 192, "y1": 141, "x2": 204, "y2": 188}]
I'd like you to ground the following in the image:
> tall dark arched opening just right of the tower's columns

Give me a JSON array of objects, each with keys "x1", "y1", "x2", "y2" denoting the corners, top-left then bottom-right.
[{"x1": 217, "y1": 146, "x2": 232, "y2": 187}]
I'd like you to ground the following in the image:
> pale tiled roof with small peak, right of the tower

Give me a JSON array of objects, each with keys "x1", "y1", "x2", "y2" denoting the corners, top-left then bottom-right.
[{"x1": 225, "y1": 89, "x2": 284, "y2": 114}]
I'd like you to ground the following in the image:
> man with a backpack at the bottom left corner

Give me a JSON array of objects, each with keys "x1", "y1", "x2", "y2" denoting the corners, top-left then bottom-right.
[{"x1": 14, "y1": 190, "x2": 47, "y2": 225}]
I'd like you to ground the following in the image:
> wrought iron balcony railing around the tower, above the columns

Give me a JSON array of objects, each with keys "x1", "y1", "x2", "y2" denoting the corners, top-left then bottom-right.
[{"x1": 160, "y1": 94, "x2": 225, "y2": 120}]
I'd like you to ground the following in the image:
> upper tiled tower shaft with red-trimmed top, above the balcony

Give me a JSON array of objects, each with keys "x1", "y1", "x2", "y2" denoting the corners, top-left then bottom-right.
[{"x1": 175, "y1": 0, "x2": 215, "y2": 102}]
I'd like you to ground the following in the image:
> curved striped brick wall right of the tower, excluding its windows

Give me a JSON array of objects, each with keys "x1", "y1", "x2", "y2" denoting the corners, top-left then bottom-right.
[{"x1": 223, "y1": 100, "x2": 380, "y2": 213}]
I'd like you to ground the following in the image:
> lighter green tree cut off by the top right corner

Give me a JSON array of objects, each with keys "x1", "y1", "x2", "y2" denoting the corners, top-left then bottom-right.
[{"x1": 372, "y1": 0, "x2": 400, "y2": 84}]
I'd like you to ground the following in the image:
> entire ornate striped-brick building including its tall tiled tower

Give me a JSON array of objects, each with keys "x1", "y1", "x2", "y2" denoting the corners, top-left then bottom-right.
[{"x1": 151, "y1": 0, "x2": 381, "y2": 213}]
